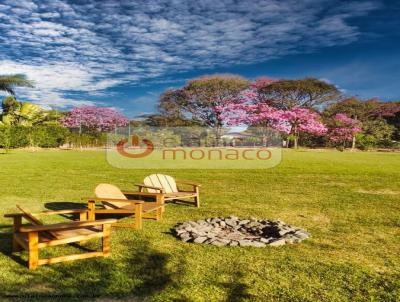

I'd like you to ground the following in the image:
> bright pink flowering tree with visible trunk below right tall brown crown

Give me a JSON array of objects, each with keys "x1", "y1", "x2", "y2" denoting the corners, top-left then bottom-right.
[{"x1": 280, "y1": 107, "x2": 327, "y2": 149}]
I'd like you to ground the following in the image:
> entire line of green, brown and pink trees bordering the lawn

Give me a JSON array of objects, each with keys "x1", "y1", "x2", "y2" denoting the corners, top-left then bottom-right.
[{"x1": 0, "y1": 75, "x2": 400, "y2": 150}]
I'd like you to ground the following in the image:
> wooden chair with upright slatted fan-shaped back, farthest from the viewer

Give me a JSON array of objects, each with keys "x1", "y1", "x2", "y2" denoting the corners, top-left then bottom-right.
[{"x1": 135, "y1": 174, "x2": 201, "y2": 208}]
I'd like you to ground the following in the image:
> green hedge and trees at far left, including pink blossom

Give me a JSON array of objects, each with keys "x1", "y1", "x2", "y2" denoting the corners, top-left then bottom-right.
[{"x1": 0, "y1": 96, "x2": 115, "y2": 149}]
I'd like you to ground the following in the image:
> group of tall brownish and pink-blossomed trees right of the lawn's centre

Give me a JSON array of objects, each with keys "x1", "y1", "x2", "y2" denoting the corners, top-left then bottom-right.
[{"x1": 135, "y1": 75, "x2": 400, "y2": 150}]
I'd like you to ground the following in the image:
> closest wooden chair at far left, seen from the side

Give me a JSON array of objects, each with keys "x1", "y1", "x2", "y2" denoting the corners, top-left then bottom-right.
[{"x1": 4, "y1": 205, "x2": 116, "y2": 270}]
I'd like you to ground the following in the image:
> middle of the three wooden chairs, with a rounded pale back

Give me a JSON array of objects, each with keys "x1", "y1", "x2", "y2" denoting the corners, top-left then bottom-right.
[{"x1": 86, "y1": 184, "x2": 163, "y2": 229}]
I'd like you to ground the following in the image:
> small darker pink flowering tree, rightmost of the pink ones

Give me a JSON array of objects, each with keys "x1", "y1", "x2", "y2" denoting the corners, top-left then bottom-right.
[{"x1": 328, "y1": 113, "x2": 362, "y2": 149}]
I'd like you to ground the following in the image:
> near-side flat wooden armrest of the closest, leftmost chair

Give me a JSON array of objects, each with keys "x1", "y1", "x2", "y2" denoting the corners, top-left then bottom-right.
[{"x1": 19, "y1": 219, "x2": 117, "y2": 233}]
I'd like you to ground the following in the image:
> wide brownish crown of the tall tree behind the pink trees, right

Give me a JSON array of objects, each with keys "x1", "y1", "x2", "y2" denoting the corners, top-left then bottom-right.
[{"x1": 255, "y1": 78, "x2": 340, "y2": 110}]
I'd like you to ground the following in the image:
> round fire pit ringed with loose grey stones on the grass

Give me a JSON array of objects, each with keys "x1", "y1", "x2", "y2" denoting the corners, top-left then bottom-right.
[{"x1": 173, "y1": 216, "x2": 310, "y2": 247}]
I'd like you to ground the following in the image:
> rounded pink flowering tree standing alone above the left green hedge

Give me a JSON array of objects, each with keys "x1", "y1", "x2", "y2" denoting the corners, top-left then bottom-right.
[{"x1": 61, "y1": 106, "x2": 129, "y2": 133}]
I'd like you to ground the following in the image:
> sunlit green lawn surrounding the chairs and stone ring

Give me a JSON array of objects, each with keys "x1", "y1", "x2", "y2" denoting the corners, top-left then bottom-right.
[{"x1": 0, "y1": 150, "x2": 400, "y2": 301}]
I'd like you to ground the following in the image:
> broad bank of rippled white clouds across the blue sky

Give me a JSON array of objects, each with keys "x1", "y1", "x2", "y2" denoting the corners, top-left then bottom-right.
[{"x1": 0, "y1": 0, "x2": 380, "y2": 106}]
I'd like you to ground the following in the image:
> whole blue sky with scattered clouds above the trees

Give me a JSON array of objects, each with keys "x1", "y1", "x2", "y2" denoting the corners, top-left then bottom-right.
[{"x1": 0, "y1": 0, "x2": 400, "y2": 117}]
